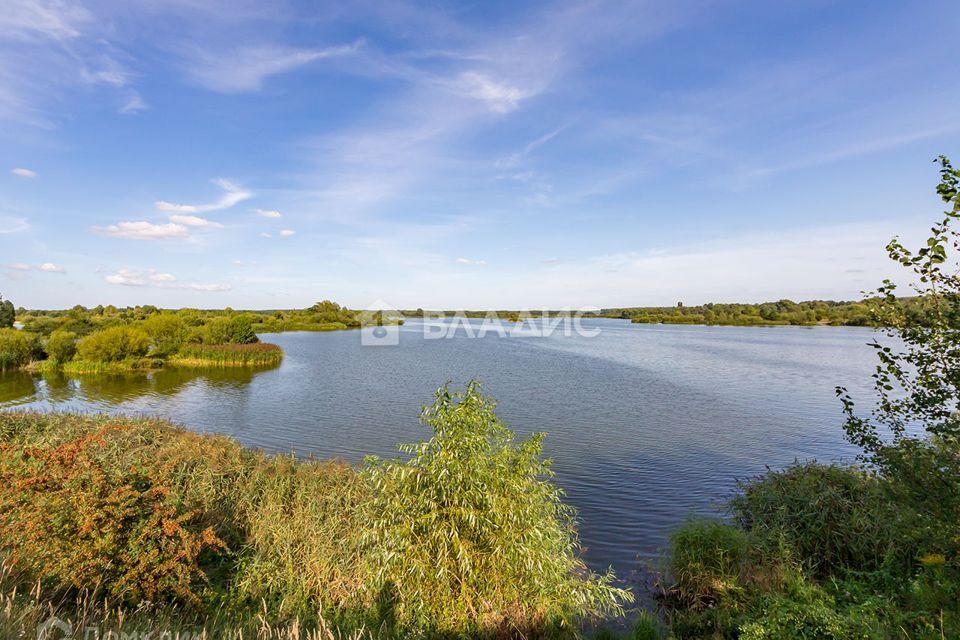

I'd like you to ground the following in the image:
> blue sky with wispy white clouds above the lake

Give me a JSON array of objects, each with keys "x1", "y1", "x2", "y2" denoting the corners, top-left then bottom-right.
[{"x1": 0, "y1": 0, "x2": 960, "y2": 309}]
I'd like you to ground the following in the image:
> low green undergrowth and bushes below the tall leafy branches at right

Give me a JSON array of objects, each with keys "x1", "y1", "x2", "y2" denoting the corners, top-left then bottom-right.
[{"x1": 661, "y1": 463, "x2": 960, "y2": 640}]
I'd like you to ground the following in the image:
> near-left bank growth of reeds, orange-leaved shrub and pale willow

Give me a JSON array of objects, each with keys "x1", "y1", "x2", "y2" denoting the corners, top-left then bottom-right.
[{"x1": 0, "y1": 383, "x2": 630, "y2": 637}]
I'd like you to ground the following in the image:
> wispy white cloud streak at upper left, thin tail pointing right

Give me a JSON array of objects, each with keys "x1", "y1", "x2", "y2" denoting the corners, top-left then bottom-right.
[{"x1": 188, "y1": 40, "x2": 363, "y2": 93}]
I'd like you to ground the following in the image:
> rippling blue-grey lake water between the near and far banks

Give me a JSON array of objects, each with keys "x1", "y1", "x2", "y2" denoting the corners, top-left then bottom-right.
[{"x1": 0, "y1": 320, "x2": 873, "y2": 577}]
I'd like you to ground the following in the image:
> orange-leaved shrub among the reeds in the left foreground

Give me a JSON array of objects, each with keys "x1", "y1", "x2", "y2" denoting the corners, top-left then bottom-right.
[{"x1": 0, "y1": 430, "x2": 222, "y2": 604}]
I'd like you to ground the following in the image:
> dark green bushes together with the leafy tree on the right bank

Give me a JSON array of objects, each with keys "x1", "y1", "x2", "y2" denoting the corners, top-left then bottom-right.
[{"x1": 662, "y1": 158, "x2": 960, "y2": 640}]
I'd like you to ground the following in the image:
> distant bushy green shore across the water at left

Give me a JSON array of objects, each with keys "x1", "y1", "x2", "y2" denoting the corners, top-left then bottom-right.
[{"x1": 0, "y1": 298, "x2": 401, "y2": 373}]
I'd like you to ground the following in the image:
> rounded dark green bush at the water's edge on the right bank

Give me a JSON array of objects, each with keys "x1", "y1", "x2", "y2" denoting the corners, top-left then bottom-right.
[{"x1": 731, "y1": 463, "x2": 911, "y2": 577}]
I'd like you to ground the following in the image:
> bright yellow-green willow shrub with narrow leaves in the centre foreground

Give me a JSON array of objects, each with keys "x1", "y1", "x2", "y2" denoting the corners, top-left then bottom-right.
[{"x1": 364, "y1": 381, "x2": 630, "y2": 632}]
